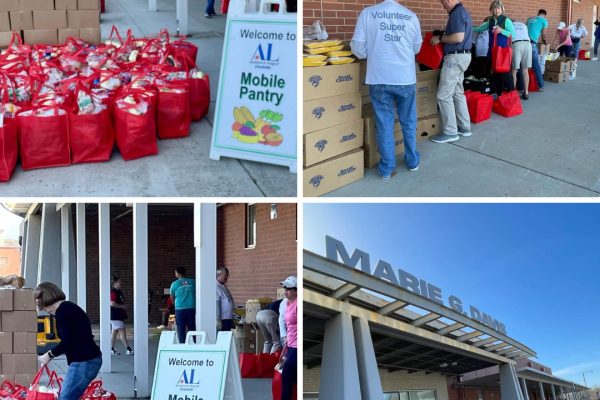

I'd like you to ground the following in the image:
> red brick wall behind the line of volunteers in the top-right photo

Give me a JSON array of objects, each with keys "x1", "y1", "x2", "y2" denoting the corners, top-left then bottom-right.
[{"x1": 303, "y1": 0, "x2": 568, "y2": 40}]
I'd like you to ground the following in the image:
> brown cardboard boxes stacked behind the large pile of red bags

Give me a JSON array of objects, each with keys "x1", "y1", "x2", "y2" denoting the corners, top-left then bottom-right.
[{"x1": 0, "y1": 0, "x2": 100, "y2": 48}]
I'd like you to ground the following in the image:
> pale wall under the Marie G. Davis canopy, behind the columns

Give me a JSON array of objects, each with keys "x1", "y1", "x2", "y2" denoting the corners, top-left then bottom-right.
[{"x1": 303, "y1": 367, "x2": 449, "y2": 400}]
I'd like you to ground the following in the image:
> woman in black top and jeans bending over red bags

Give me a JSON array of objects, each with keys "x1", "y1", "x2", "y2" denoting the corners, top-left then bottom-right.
[{"x1": 33, "y1": 282, "x2": 102, "y2": 400}]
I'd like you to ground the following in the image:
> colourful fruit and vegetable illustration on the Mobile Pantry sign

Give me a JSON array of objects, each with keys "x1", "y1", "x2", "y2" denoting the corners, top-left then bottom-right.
[{"x1": 231, "y1": 107, "x2": 283, "y2": 146}]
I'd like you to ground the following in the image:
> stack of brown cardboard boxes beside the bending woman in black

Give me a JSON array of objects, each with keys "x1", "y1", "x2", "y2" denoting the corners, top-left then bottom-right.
[{"x1": 0, "y1": 288, "x2": 38, "y2": 388}]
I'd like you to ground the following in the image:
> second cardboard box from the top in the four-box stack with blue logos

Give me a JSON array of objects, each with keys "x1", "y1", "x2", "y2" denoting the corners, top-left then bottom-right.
[{"x1": 303, "y1": 92, "x2": 361, "y2": 134}]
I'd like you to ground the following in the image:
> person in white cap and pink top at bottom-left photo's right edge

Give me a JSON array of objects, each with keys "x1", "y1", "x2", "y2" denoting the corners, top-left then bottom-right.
[{"x1": 279, "y1": 276, "x2": 298, "y2": 400}]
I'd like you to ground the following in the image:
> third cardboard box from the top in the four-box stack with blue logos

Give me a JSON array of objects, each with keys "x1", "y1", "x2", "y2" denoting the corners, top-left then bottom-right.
[{"x1": 303, "y1": 119, "x2": 363, "y2": 167}]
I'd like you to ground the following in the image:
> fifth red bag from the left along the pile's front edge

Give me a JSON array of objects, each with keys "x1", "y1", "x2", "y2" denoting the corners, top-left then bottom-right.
[{"x1": 156, "y1": 82, "x2": 191, "y2": 139}]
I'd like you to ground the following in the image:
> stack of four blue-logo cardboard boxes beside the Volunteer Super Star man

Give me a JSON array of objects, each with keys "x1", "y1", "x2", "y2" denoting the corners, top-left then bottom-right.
[{"x1": 303, "y1": 63, "x2": 364, "y2": 197}]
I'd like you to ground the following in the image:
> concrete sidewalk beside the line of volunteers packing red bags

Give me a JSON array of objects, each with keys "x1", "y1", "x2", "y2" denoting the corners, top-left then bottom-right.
[{"x1": 326, "y1": 61, "x2": 600, "y2": 197}]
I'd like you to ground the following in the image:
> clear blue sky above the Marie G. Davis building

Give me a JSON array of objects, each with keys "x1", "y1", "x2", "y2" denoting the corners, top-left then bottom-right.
[{"x1": 303, "y1": 204, "x2": 600, "y2": 386}]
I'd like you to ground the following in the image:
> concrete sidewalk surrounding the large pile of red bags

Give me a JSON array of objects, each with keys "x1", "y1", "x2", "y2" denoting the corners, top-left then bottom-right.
[{"x1": 0, "y1": 0, "x2": 296, "y2": 197}]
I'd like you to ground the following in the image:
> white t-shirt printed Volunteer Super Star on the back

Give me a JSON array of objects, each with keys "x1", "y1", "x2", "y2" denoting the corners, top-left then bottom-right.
[{"x1": 352, "y1": 0, "x2": 423, "y2": 85}]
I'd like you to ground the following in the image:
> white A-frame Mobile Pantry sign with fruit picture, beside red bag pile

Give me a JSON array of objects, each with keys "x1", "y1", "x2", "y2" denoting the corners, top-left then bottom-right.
[{"x1": 210, "y1": 0, "x2": 298, "y2": 173}]
